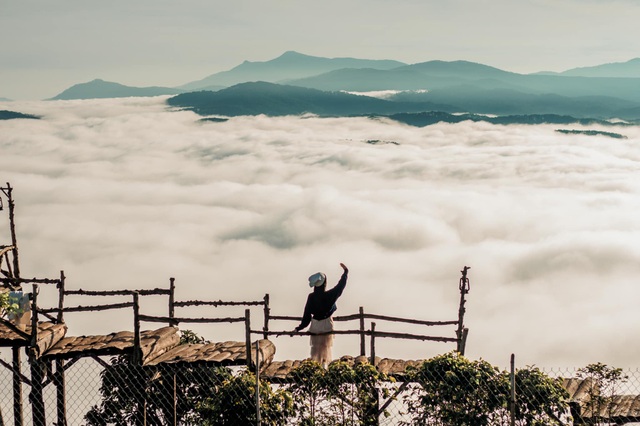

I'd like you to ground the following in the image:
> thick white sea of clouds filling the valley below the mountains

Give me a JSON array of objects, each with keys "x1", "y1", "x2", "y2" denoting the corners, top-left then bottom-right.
[{"x1": 0, "y1": 97, "x2": 640, "y2": 367}]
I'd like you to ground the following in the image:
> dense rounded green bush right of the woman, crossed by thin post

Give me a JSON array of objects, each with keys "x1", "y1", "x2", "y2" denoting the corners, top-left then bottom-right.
[{"x1": 404, "y1": 352, "x2": 568, "y2": 426}]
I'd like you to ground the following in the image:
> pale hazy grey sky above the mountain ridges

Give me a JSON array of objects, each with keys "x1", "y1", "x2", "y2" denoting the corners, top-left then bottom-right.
[{"x1": 0, "y1": 0, "x2": 640, "y2": 99}]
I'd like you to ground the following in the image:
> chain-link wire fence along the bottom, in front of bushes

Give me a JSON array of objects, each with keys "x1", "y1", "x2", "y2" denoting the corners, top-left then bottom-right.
[{"x1": 0, "y1": 353, "x2": 640, "y2": 426}]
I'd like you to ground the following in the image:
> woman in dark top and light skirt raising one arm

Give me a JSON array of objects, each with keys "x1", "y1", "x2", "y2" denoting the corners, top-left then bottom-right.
[{"x1": 295, "y1": 263, "x2": 349, "y2": 367}]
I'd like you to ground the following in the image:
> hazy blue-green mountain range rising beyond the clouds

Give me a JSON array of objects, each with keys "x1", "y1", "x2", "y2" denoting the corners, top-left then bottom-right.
[{"x1": 8, "y1": 52, "x2": 640, "y2": 121}]
